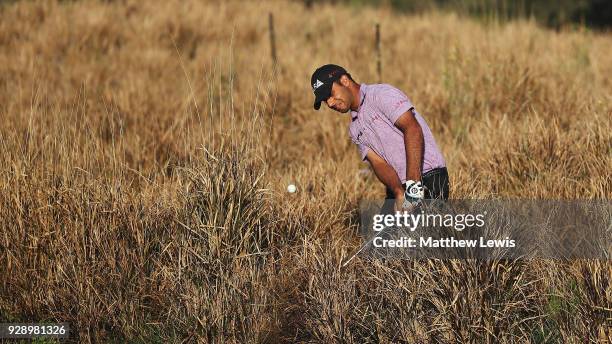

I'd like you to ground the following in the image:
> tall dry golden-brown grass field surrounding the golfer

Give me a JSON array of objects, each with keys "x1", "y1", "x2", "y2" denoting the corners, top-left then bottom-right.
[{"x1": 0, "y1": 0, "x2": 612, "y2": 343}]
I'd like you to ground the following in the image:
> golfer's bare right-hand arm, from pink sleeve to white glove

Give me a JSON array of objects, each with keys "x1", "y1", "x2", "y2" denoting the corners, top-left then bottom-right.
[{"x1": 395, "y1": 109, "x2": 425, "y2": 182}]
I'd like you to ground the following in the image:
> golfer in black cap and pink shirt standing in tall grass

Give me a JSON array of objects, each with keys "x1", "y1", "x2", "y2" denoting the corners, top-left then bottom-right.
[{"x1": 310, "y1": 64, "x2": 449, "y2": 212}]
